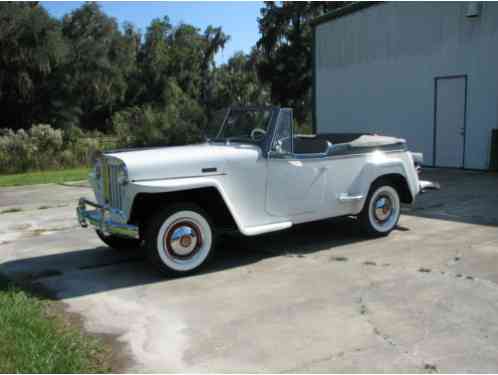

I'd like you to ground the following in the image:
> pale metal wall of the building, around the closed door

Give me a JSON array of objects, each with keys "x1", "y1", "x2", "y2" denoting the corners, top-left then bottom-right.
[{"x1": 314, "y1": 2, "x2": 498, "y2": 169}]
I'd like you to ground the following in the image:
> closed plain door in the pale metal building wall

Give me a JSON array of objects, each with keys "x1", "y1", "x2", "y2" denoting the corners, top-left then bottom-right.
[{"x1": 434, "y1": 76, "x2": 467, "y2": 168}]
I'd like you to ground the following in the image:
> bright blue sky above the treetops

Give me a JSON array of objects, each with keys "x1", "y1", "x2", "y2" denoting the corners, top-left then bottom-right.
[{"x1": 41, "y1": 1, "x2": 263, "y2": 64}]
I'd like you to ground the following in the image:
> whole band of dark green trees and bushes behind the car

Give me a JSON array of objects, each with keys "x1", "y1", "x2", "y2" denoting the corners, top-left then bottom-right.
[{"x1": 0, "y1": 2, "x2": 350, "y2": 173}]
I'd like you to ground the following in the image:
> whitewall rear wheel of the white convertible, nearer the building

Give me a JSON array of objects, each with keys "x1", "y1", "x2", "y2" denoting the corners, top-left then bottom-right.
[{"x1": 359, "y1": 181, "x2": 401, "y2": 236}]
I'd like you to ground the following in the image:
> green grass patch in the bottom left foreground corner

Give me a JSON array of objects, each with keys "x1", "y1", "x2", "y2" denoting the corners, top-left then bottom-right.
[{"x1": 0, "y1": 277, "x2": 110, "y2": 373}]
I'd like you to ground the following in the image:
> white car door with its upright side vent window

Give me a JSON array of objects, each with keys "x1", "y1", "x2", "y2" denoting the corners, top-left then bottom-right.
[{"x1": 266, "y1": 109, "x2": 327, "y2": 217}]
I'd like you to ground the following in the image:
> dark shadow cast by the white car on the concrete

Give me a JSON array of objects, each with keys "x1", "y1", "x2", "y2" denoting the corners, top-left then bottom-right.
[{"x1": 2, "y1": 218, "x2": 375, "y2": 299}]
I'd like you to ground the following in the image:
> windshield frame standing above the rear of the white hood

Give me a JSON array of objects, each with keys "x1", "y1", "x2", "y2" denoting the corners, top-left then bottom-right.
[{"x1": 209, "y1": 106, "x2": 279, "y2": 155}]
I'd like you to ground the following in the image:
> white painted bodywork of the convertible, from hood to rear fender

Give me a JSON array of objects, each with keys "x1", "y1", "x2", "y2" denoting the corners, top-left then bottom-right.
[{"x1": 91, "y1": 143, "x2": 419, "y2": 236}]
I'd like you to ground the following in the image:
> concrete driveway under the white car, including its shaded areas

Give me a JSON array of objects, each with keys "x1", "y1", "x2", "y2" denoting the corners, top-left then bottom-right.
[{"x1": 0, "y1": 170, "x2": 498, "y2": 372}]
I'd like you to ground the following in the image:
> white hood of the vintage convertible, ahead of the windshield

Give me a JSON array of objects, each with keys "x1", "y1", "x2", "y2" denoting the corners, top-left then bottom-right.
[{"x1": 105, "y1": 143, "x2": 259, "y2": 181}]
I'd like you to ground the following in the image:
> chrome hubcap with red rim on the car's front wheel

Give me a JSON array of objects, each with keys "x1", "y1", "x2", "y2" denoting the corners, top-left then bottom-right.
[{"x1": 165, "y1": 222, "x2": 202, "y2": 258}]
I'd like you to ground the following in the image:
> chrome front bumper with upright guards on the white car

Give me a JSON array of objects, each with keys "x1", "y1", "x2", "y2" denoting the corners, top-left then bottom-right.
[{"x1": 76, "y1": 198, "x2": 139, "y2": 239}]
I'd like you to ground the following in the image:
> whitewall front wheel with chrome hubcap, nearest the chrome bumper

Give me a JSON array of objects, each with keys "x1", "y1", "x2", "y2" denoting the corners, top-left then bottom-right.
[{"x1": 145, "y1": 204, "x2": 215, "y2": 276}]
